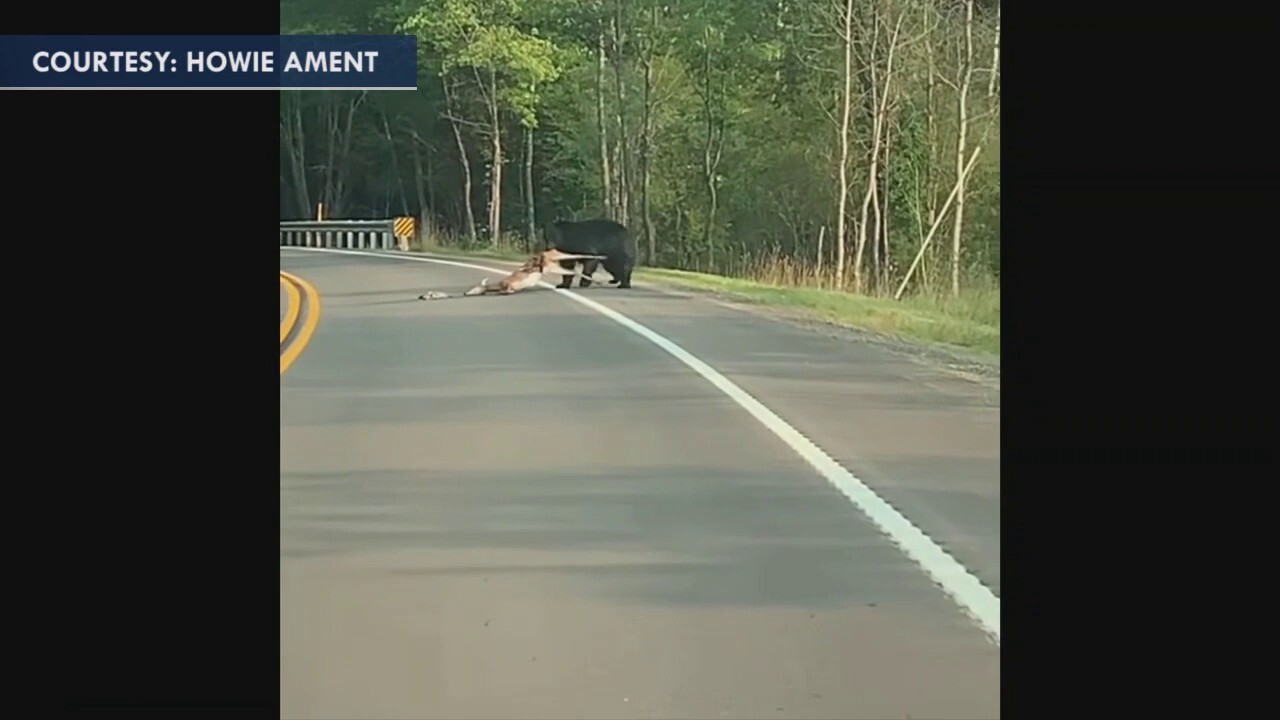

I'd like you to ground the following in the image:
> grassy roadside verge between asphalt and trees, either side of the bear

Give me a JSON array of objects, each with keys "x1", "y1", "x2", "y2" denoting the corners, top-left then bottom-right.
[{"x1": 422, "y1": 235, "x2": 1000, "y2": 357}]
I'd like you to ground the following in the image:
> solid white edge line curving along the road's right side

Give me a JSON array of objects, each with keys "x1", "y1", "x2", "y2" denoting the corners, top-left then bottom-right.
[{"x1": 280, "y1": 246, "x2": 1000, "y2": 647}]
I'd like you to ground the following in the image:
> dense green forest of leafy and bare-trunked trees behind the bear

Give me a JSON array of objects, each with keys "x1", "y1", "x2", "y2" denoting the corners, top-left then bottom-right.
[{"x1": 279, "y1": 0, "x2": 1001, "y2": 333}]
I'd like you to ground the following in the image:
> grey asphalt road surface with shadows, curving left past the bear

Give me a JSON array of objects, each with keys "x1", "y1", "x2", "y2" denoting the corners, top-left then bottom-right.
[{"x1": 280, "y1": 250, "x2": 1000, "y2": 719}]
